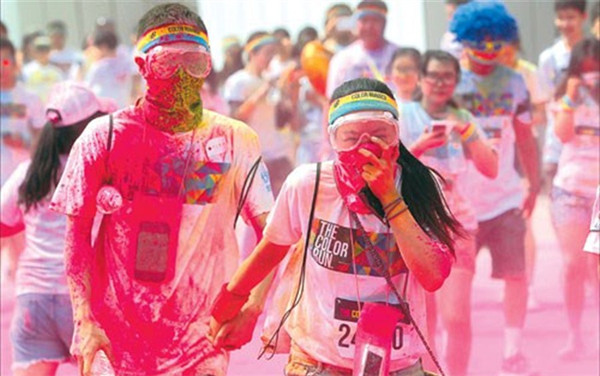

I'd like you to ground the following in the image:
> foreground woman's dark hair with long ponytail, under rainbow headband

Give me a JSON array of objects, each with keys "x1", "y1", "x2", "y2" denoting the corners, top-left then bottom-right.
[{"x1": 331, "y1": 78, "x2": 463, "y2": 253}]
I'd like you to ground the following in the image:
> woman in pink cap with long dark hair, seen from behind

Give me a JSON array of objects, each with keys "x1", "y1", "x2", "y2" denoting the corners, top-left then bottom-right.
[{"x1": 0, "y1": 82, "x2": 116, "y2": 376}]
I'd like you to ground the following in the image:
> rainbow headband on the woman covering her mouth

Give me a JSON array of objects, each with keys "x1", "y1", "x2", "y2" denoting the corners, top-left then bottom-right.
[{"x1": 329, "y1": 91, "x2": 398, "y2": 125}]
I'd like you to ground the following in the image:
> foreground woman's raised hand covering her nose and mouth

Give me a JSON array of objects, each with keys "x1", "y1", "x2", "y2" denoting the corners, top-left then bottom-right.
[{"x1": 358, "y1": 137, "x2": 399, "y2": 205}]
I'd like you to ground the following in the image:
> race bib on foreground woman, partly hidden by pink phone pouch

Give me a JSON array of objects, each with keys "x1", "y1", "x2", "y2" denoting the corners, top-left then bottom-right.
[{"x1": 334, "y1": 298, "x2": 410, "y2": 359}]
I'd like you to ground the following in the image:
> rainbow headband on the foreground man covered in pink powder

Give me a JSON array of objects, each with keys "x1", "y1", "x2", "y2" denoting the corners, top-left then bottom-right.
[{"x1": 136, "y1": 24, "x2": 210, "y2": 53}]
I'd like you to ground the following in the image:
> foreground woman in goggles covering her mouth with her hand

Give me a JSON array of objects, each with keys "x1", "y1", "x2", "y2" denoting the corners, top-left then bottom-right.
[{"x1": 212, "y1": 78, "x2": 461, "y2": 376}]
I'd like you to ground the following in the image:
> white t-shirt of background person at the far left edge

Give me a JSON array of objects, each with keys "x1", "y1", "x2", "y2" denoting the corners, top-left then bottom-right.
[{"x1": 0, "y1": 84, "x2": 45, "y2": 185}]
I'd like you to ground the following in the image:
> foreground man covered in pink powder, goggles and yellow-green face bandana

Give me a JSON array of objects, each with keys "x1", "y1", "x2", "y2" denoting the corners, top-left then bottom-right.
[{"x1": 52, "y1": 4, "x2": 273, "y2": 376}]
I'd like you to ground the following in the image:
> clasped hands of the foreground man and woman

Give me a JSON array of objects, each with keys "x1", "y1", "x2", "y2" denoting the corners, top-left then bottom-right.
[{"x1": 208, "y1": 307, "x2": 261, "y2": 351}]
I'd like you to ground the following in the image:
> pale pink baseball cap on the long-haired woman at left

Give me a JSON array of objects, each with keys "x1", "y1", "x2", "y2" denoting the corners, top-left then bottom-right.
[{"x1": 46, "y1": 81, "x2": 118, "y2": 128}]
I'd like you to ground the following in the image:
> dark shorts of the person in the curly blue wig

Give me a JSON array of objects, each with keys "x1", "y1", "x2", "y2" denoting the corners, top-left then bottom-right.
[{"x1": 477, "y1": 209, "x2": 525, "y2": 279}]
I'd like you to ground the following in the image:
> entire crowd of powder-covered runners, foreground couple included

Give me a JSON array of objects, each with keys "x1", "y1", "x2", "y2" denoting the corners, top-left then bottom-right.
[{"x1": 0, "y1": 0, "x2": 600, "y2": 376}]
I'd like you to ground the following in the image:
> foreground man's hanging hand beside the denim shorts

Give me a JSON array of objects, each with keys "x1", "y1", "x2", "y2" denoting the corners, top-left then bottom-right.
[{"x1": 77, "y1": 320, "x2": 114, "y2": 376}]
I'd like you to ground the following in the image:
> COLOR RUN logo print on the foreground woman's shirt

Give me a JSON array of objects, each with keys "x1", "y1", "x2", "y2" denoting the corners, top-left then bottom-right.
[{"x1": 309, "y1": 219, "x2": 407, "y2": 277}]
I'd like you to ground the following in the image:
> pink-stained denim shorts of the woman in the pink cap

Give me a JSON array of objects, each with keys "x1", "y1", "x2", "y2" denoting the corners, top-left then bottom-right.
[{"x1": 10, "y1": 294, "x2": 73, "y2": 370}]
